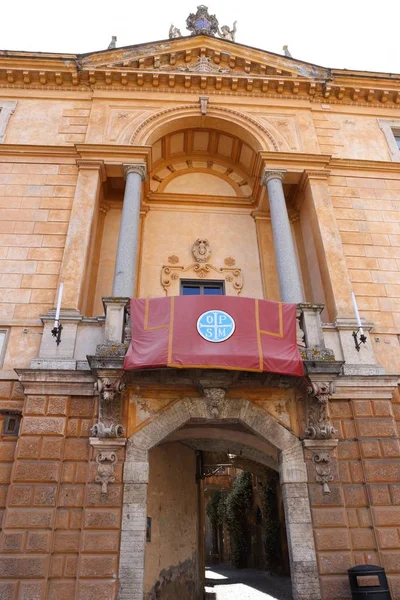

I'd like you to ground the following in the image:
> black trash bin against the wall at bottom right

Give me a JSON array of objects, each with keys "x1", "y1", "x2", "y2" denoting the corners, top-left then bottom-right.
[{"x1": 347, "y1": 565, "x2": 391, "y2": 600}]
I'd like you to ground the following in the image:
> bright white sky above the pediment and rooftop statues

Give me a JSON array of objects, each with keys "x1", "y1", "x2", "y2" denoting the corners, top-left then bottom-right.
[{"x1": 0, "y1": 0, "x2": 400, "y2": 73}]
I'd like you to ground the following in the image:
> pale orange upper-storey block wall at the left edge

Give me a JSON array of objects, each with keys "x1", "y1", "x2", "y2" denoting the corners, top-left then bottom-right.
[{"x1": 0, "y1": 157, "x2": 78, "y2": 371}]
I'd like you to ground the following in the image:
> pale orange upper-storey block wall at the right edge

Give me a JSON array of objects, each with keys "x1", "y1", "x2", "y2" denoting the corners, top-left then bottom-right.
[{"x1": 329, "y1": 175, "x2": 400, "y2": 373}]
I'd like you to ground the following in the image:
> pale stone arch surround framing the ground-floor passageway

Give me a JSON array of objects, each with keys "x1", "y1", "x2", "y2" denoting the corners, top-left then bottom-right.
[{"x1": 118, "y1": 394, "x2": 320, "y2": 600}]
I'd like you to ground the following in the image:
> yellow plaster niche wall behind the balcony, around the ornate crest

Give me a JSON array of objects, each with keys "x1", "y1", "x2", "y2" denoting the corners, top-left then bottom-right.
[{"x1": 139, "y1": 207, "x2": 263, "y2": 298}]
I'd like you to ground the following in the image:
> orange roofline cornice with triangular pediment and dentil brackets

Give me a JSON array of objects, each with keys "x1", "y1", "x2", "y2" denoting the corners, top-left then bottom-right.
[{"x1": 0, "y1": 35, "x2": 400, "y2": 108}]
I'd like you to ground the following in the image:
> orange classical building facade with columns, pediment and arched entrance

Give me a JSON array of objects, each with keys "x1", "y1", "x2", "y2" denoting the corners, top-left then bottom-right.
[{"x1": 0, "y1": 7, "x2": 400, "y2": 600}]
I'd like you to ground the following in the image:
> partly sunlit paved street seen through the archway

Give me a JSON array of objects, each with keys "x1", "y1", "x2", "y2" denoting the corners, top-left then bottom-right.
[{"x1": 206, "y1": 565, "x2": 292, "y2": 600}]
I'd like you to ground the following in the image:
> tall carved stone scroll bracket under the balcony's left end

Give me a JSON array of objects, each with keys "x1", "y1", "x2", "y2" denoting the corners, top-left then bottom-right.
[{"x1": 90, "y1": 376, "x2": 125, "y2": 438}]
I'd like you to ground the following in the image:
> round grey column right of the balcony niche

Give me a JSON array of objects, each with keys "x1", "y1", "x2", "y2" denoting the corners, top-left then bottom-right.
[{"x1": 262, "y1": 169, "x2": 303, "y2": 304}]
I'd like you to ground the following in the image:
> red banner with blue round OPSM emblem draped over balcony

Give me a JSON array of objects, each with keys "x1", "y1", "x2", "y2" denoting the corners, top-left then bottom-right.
[{"x1": 124, "y1": 296, "x2": 303, "y2": 376}]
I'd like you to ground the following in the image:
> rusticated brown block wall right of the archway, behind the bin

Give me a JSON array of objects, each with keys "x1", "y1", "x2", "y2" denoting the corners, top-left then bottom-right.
[{"x1": 307, "y1": 388, "x2": 400, "y2": 600}]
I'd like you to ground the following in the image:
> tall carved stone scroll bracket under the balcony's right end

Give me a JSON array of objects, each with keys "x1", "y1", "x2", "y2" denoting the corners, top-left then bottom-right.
[{"x1": 305, "y1": 382, "x2": 336, "y2": 440}]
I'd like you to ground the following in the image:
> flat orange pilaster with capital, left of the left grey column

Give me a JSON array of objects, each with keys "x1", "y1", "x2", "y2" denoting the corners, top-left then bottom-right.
[{"x1": 60, "y1": 160, "x2": 105, "y2": 310}]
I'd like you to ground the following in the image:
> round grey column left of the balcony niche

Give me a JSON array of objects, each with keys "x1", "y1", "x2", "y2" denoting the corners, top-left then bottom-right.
[{"x1": 112, "y1": 163, "x2": 146, "y2": 298}]
